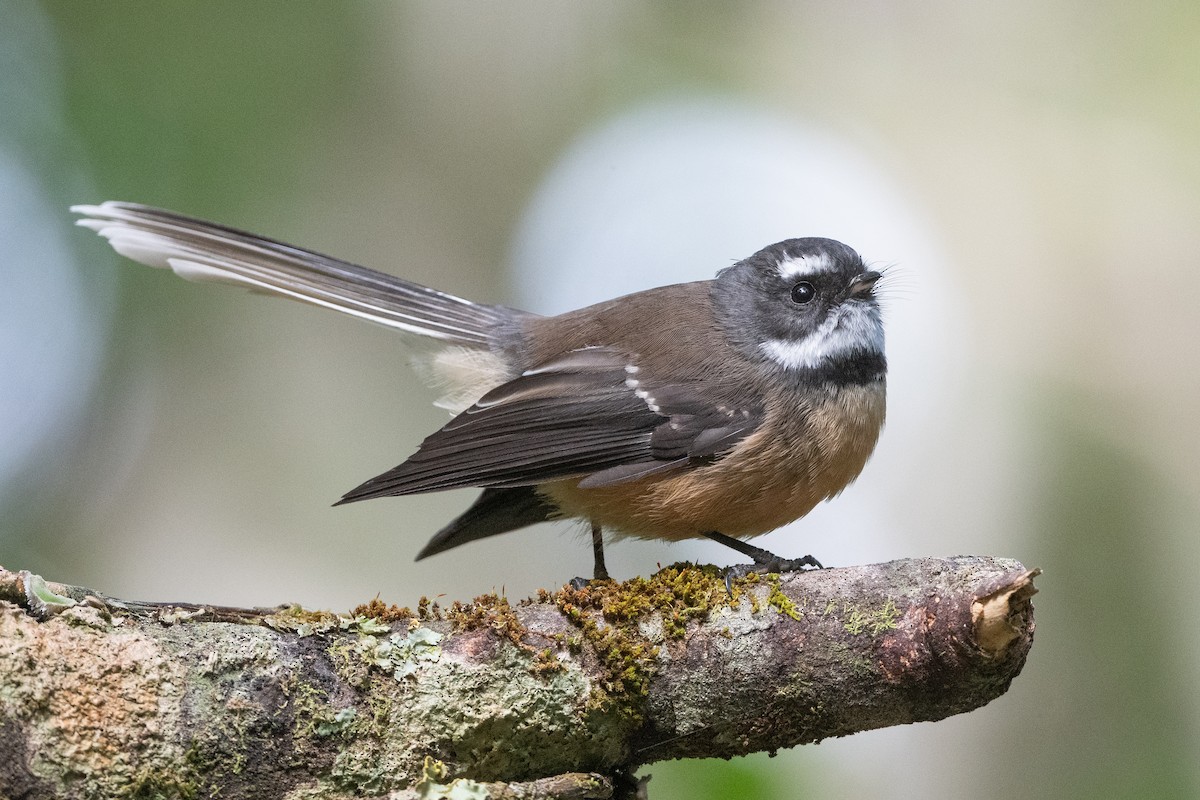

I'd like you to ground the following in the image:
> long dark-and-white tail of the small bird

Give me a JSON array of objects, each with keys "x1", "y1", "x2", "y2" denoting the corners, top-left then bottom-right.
[{"x1": 71, "y1": 200, "x2": 517, "y2": 348}]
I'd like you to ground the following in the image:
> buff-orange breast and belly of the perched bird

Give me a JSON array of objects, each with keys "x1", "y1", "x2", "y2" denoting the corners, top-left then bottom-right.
[{"x1": 541, "y1": 380, "x2": 886, "y2": 539}]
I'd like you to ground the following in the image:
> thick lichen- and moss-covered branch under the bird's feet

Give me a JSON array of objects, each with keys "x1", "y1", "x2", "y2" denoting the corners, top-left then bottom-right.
[{"x1": 0, "y1": 557, "x2": 1038, "y2": 799}]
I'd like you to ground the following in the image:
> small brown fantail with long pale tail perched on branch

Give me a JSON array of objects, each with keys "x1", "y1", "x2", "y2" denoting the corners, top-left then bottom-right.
[{"x1": 71, "y1": 200, "x2": 887, "y2": 581}]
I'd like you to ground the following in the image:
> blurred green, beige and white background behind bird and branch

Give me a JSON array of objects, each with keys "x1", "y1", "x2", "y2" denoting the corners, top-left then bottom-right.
[{"x1": 0, "y1": 0, "x2": 1200, "y2": 800}]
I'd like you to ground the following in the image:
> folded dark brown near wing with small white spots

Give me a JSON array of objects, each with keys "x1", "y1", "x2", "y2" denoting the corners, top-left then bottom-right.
[{"x1": 341, "y1": 347, "x2": 761, "y2": 503}]
